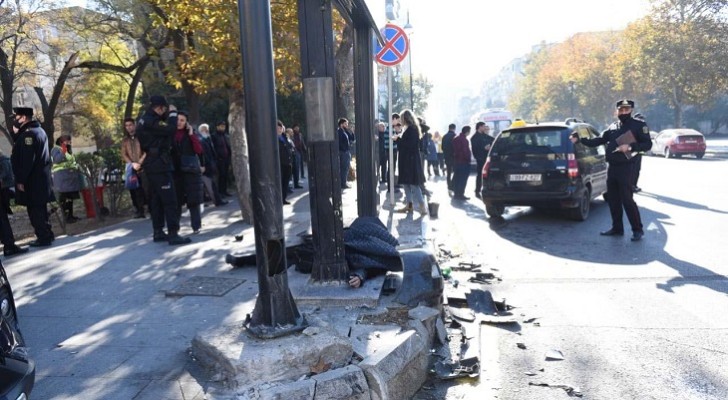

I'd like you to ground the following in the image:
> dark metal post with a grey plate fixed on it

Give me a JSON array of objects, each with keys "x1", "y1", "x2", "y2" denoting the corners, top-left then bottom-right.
[{"x1": 298, "y1": 0, "x2": 349, "y2": 285}]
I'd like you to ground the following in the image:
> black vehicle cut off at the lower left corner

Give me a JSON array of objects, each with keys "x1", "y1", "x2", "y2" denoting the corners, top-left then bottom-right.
[{"x1": 0, "y1": 262, "x2": 35, "y2": 400}]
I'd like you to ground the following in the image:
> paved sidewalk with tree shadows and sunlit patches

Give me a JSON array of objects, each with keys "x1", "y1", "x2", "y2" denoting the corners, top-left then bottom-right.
[{"x1": 3, "y1": 179, "x2": 438, "y2": 400}]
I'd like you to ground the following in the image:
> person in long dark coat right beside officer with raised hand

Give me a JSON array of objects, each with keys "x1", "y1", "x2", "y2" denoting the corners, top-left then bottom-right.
[{"x1": 172, "y1": 111, "x2": 204, "y2": 233}]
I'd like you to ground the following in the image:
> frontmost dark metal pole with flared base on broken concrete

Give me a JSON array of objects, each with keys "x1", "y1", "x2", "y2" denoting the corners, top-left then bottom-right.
[{"x1": 238, "y1": 0, "x2": 306, "y2": 338}]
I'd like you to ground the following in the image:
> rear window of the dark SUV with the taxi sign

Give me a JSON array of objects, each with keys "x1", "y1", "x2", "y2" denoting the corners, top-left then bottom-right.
[{"x1": 493, "y1": 128, "x2": 567, "y2": 155}]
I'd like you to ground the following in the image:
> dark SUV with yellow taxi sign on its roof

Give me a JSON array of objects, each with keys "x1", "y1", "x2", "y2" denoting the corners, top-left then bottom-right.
[{"x1": 481, "y1": 118, "x2": 607, "y2": 221}]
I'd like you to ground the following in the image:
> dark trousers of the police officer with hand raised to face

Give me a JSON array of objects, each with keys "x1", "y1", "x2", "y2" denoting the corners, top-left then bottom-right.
[{"x1": 142, "y1": 172, "x2": 179, "y2": 235}]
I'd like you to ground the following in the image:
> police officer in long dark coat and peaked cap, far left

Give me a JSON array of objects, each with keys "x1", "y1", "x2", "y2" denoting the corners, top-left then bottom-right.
[{"x1": 10, "y1": 107, "x2": 55, "y2": 247}]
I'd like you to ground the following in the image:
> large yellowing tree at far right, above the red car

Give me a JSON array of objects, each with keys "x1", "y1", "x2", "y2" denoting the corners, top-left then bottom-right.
[{"x1": 626, "y1": 0, "x2": 728, "y2": 127}]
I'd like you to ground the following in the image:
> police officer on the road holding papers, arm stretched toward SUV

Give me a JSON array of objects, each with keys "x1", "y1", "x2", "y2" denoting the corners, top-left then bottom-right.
[{"x1": 571, "y1": 100, "x2": 652, "y2": 241}]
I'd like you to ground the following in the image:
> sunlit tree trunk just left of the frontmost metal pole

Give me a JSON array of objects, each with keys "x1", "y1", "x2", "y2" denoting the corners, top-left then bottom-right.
[{"x1": 228, "y1": 90, "x2": 253, "y2": 225}]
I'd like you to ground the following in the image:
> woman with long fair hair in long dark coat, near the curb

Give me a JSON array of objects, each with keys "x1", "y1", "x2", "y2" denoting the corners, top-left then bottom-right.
[{"x1": 397, "y1": 110, "x2": 427, "y2": 215}]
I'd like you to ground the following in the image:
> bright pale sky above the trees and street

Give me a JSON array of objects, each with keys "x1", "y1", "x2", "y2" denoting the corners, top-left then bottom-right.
[{"x1": 66, "y1": 0, "x2": 649, "y2": 124}]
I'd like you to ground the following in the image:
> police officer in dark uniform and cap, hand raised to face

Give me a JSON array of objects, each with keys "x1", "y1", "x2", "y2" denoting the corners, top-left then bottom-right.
[{"x1": 136, "y1": 95, "x2": 191, "y2": 245}]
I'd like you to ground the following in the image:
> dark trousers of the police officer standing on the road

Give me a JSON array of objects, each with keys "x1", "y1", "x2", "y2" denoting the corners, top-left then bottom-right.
[{"x1": 607, "y1": 163, "x2": 642, "y2": 232}]
